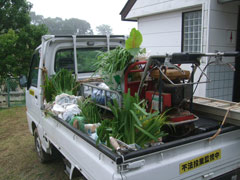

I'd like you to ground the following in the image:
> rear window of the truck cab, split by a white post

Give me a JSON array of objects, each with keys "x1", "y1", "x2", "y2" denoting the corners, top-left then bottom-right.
[{"x1": 55, "y1": 48, "x2": 106, "y2": 73}]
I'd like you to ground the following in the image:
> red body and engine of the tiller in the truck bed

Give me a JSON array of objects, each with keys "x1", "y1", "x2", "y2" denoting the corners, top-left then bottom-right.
[{"x1": 124, "y1": 57, "x2": 197, "y2": 123}]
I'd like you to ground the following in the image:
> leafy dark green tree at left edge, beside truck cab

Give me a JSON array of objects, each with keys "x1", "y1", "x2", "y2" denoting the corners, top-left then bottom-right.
[{"x1": 0, "y1": 0, "x2": 47, "y2": 80}]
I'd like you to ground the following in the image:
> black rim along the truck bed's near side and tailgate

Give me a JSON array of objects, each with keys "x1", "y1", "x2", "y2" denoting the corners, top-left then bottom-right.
[{"x1": 54, "y1": 112, "x2": 240, "y2": 164}]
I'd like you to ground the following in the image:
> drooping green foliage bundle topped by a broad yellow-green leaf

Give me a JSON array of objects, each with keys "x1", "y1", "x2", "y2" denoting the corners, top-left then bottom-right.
[{"x1": 95, "y1": 28, "x2": 145, "y2": 90}]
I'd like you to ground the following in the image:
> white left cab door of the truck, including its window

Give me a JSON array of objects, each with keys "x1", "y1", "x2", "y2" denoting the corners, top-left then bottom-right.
[{"x1": 26, "y1": 52, "x2": 41, "y2": 127}]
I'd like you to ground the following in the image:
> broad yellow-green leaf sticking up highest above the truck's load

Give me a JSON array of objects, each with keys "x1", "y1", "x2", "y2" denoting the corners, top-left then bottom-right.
[{"x1": 126, "y1": 28, "x2": 143, "y2": 50}]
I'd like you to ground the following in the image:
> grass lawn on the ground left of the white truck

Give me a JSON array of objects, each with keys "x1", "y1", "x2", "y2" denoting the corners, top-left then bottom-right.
[{"x1": 0, "y1": 107, "x2": 68, "y2": 180}]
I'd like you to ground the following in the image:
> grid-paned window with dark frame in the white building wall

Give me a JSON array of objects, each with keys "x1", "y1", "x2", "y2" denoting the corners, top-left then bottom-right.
[{"x1": 182, "y1": 10, "x2": 202, "y2": 52}]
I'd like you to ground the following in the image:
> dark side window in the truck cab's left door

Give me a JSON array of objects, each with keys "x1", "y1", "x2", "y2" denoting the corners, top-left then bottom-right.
[{"x1": 27, "y1": 53, "x2": 40, "y2": 89}]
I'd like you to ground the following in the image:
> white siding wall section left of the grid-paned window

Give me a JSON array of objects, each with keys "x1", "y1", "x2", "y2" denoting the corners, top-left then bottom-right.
[{"x1": 138, "y1": 11, "x2": 182, "y2": 54}]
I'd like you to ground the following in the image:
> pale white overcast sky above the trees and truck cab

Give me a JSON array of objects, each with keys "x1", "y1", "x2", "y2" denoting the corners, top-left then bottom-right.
[{"x1": 28, "y1": 0, "x2": 137, "y2": 35}]
